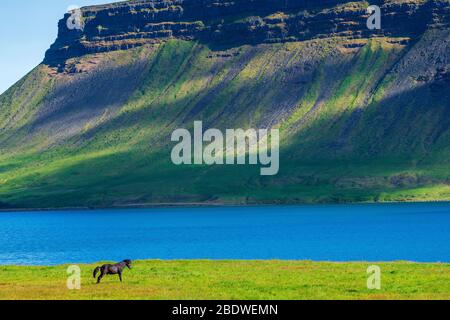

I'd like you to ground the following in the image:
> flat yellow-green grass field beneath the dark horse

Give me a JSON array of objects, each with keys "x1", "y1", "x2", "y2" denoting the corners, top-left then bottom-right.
[{"x1": 0, "y1": 261, "x2": 450, "y2": 300}]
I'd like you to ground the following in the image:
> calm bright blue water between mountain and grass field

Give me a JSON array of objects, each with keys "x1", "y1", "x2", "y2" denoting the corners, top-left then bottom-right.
[{"x1": 0, "y1": 203, "x2": 450, "y2": 265}]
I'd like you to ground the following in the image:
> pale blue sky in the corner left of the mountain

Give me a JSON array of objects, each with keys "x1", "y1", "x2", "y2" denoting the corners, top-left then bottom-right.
[{"x1": 0, "y1": 0, "x2": 121, "y2": 94}]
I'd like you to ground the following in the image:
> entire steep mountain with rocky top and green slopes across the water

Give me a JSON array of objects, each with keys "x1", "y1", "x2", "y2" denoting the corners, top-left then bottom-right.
[{"x1": 0, "y1": 0, "x2": 450, "y2": 208}]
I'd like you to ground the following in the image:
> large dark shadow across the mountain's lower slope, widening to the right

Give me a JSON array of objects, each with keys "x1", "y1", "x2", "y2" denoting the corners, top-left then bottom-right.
[{"x1": 3, "y1": 76, "x2": 450, "y2": 207}]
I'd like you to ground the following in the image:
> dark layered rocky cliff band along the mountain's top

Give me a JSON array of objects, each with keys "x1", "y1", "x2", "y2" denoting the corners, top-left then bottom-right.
[{"x1": 45, "y1": 0, "x2": 450, "y2": 65}]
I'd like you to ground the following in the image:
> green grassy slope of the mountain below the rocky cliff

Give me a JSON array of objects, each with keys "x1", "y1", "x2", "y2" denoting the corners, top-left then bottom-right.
[{"x1": 0, "y1": 38, "x2": 450, "y2": 208}]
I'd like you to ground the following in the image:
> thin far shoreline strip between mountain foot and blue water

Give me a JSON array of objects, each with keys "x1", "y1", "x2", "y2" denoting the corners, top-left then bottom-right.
[{"x1": 0, "y1": 200, "x2": 450, "y2": 213}]
